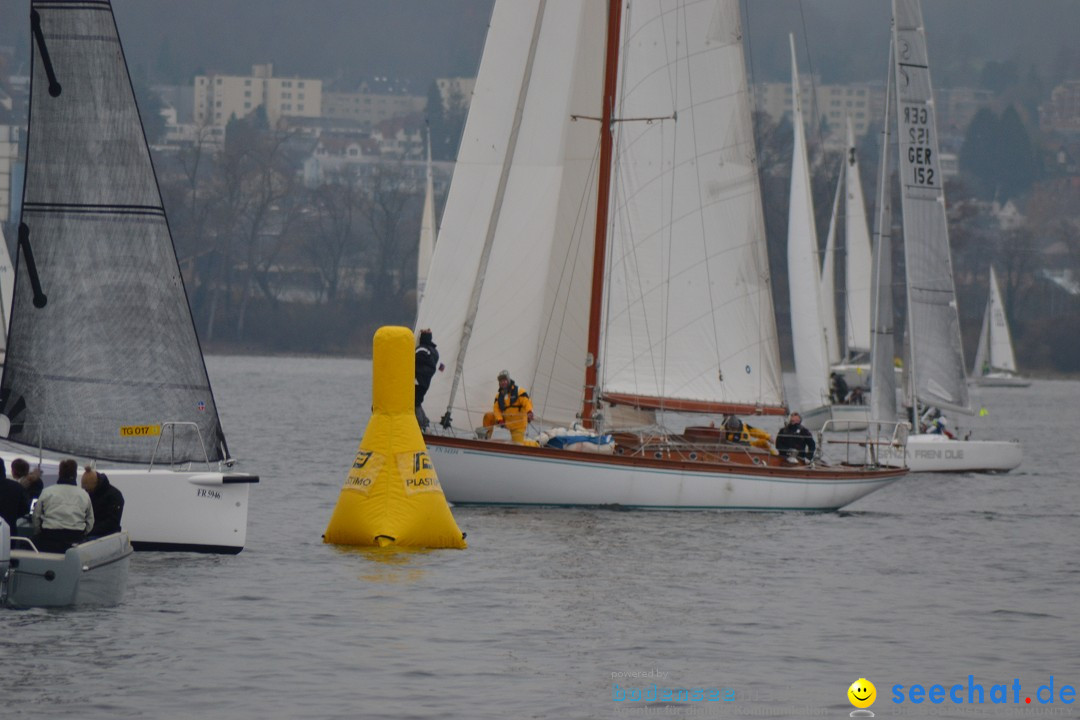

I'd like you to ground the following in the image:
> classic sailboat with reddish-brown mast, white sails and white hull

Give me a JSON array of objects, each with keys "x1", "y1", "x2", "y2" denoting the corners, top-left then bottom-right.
[{"x1": 418, "y1": 0, "x2": 903, "y2": 511}]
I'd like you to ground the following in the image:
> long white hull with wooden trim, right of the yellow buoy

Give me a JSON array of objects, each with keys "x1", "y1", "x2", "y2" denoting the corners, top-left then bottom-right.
[{"x1": 424, "y1": 436, "x2": 906, "y2": 512}]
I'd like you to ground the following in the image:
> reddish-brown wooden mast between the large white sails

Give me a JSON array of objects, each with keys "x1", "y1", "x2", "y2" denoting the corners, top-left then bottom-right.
[{"x1": 581, "y1": 0, "x2": 623, "y2": 427}]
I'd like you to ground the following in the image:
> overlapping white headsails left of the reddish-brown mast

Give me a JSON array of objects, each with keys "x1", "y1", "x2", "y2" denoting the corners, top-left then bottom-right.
[{"x1": 417, "y1": 0, "x2": 607, "y2": 426}]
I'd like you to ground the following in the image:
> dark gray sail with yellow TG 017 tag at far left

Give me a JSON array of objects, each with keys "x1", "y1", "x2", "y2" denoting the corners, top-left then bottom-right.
[{"x1": 0, "y1": 0, "x2": 228, "y2": 462}]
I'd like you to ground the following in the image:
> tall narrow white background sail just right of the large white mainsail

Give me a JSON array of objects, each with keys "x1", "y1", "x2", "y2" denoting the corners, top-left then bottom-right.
[{"x1": 787, "y1": 36, "x2": 828, "y2": 411}]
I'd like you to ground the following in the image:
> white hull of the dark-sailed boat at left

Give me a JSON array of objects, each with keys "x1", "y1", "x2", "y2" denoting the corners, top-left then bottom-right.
[{"x1": 0, "y1": 450, "x2": 259, "y2": 555}]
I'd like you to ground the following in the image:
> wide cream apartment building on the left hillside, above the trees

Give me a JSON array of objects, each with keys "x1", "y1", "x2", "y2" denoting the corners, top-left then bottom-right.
[{"x1": 194, "y1": 64, "x2": 323, "y2": 127}]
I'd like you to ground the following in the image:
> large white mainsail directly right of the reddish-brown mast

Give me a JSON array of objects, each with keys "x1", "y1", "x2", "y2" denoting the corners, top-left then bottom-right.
[{"x1": 600, "y1": 0, "x2": 783, "y2": 407}]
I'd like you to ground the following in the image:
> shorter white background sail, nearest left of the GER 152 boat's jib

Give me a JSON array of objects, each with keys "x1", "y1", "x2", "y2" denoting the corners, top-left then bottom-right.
[{"x1": 843, "y1": 117, "x2": 872, "y2": 356}]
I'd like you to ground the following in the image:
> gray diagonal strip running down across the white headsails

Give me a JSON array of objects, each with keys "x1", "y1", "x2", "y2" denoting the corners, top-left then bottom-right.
[{"x1": 440, "y1": 0, "x2": 548, "y2": 429}]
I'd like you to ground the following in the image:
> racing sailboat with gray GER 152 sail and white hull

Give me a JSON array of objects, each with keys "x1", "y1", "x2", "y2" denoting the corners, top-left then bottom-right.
[{"x1": 874, "y1": 0, "x2": 1023, "y2": 472}]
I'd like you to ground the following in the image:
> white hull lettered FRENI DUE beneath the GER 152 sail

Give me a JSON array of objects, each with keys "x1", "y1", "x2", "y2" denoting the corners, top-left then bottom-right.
[{"x1": 885, "y1": 435, "x2": 1024, "y2": 473}]
